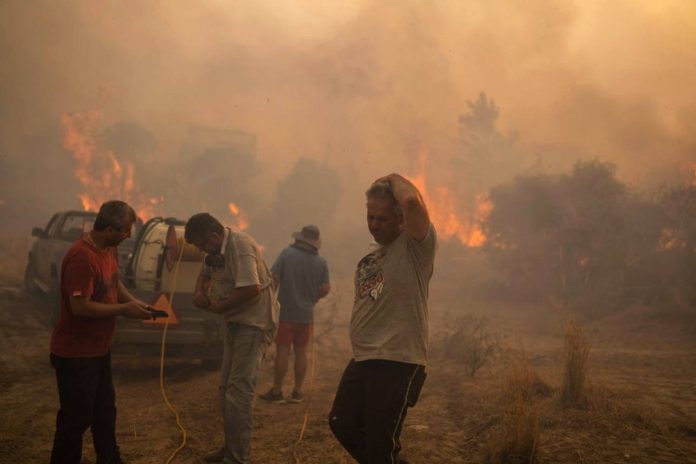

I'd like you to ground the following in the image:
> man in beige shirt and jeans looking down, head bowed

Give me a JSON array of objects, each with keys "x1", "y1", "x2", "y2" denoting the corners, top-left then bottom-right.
[{"x1": 184, "y1": 213, "x2": 279, "y2": 464}]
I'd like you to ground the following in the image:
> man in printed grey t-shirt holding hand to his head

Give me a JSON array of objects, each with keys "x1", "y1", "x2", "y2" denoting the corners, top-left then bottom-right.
[{"x1": 329, "y1": 174, "x2": 437, "y2": 463}]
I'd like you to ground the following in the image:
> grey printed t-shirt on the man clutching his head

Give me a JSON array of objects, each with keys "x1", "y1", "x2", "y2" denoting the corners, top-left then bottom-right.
[{"x1": 350, "y1": 224, "x2": 437, "y2": 365}]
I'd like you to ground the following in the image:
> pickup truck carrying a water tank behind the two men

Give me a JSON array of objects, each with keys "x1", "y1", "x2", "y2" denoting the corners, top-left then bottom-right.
[{"x1": 24, "y1": 211, "x2": 224, "y2": 367}]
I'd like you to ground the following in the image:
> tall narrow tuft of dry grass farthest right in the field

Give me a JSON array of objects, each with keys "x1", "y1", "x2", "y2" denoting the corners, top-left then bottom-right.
[{"x1": 561, "y1": 322, "x2": 590, "y2": 406}]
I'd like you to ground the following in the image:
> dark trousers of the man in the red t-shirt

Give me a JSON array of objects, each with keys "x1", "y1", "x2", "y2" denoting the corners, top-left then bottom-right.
[{"x1": 51, "y1": 354, "x2": 121, "y2": 464}]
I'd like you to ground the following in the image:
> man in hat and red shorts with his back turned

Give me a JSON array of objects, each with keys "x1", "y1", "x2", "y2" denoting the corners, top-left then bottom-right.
[{"x1": 260, "y1": 225, "x2": 331, "y2": 403}]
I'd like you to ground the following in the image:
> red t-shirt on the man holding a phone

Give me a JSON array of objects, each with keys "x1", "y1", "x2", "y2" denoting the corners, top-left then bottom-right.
[{"x1": 51, "y1": 238, "x2": 119, "y2": 358}]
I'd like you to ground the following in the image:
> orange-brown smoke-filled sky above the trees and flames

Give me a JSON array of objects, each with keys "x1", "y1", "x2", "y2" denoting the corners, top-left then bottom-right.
[{"x1": 0, "y1": 0, "x2": 696, "y2": 232}]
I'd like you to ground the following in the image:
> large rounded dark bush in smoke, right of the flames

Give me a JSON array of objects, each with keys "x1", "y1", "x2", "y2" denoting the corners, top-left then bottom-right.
[{"x1": 484, "y1": 160, "x2": 660, "y2": 314}]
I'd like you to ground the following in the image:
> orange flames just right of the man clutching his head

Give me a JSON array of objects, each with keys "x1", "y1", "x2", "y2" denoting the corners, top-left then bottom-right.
[{"x1": 408, "y1": 153, "x2": 493, "y2": 247}]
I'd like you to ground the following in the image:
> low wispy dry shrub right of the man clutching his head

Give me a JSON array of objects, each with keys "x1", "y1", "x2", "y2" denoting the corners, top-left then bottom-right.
[{"x1": 435, "y1": 316, "x2": 500, "y2": 377}]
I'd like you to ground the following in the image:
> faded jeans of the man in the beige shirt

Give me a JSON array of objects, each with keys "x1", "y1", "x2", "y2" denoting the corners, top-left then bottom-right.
[{"x1": 220, "y1": 323, "x2": 271, "y2": 464}]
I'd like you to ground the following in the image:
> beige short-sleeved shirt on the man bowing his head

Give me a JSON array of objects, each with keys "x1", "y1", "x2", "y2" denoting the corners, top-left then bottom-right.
[{"x1": 202, "y1": 229, "x2": 280, "y2": 332}]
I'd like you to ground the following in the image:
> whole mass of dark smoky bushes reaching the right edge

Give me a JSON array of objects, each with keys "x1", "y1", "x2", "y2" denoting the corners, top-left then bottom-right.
[{"x1": 483, "y1": 160, "x2": 696, "y2": 317}]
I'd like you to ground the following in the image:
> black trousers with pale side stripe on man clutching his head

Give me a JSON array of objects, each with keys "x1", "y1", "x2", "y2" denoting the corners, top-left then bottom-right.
[{"x1": 329, "y1": 360, "x2": 425, "y2": 464}]
